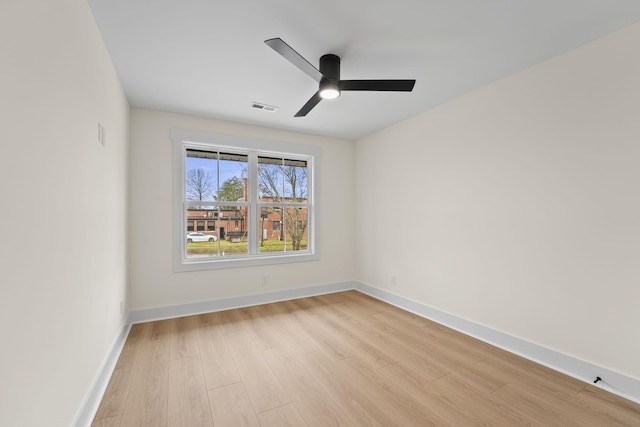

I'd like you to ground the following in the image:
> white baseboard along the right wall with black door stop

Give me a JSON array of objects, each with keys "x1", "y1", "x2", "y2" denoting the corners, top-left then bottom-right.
[{"x1": 355, "y1": 282, "x2": 640, "y2": 403}]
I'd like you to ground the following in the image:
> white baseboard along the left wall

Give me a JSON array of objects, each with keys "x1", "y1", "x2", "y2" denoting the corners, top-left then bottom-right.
[{"x1": 71, "y1": 324, "x2": 131, "y2": 427}]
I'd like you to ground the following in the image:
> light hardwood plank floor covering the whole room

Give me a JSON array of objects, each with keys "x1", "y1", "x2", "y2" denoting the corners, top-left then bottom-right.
[{"x1": 93, "y1": 291, "x2": 640, "y2": 427}]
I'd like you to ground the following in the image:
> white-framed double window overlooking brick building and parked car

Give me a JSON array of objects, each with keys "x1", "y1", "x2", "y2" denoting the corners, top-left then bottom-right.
[{"x1": 171, "y1": 129, "x2": 320, "y2": 271}]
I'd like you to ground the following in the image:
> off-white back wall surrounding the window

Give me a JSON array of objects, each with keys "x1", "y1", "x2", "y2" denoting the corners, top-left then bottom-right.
[{"x1": 129, "y1": 109, "x2": 355, "y2": 310}]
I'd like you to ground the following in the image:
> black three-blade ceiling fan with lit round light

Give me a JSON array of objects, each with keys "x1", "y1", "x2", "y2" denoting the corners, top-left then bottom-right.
[{"x1": 264, "y1": 38, "x2": 416, "y2": 117}]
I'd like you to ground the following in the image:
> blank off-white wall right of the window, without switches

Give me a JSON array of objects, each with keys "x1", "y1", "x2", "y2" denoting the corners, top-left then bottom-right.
[{"x1": 356, "y1": 24, "x2": 640, "y2": 379}]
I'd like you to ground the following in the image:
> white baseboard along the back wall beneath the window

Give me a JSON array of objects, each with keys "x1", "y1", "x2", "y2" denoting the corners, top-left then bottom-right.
[{"x1": 129, "y1": 281, "x2": 356, "y2": 323}]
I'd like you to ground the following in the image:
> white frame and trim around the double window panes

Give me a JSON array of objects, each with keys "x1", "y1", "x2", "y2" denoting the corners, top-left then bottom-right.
[{"x1": 171, "y1": 128, "x2": 321, "y2": 272}]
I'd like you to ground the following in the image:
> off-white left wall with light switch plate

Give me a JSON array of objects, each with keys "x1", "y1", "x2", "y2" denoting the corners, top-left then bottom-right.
[{"x1": 0, "y1": 0, "x2": 129, "y2": 427}]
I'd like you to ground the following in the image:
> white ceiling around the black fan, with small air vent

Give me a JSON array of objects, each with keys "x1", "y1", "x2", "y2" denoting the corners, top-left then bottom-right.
[{"x1": 88, "y1": 0, "x2": 640, "y2": 139}]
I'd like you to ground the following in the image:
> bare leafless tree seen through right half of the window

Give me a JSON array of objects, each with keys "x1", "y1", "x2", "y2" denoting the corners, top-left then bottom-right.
[{"x1": 258, "y1": 161, "x2": 308, "y2": 251}]
